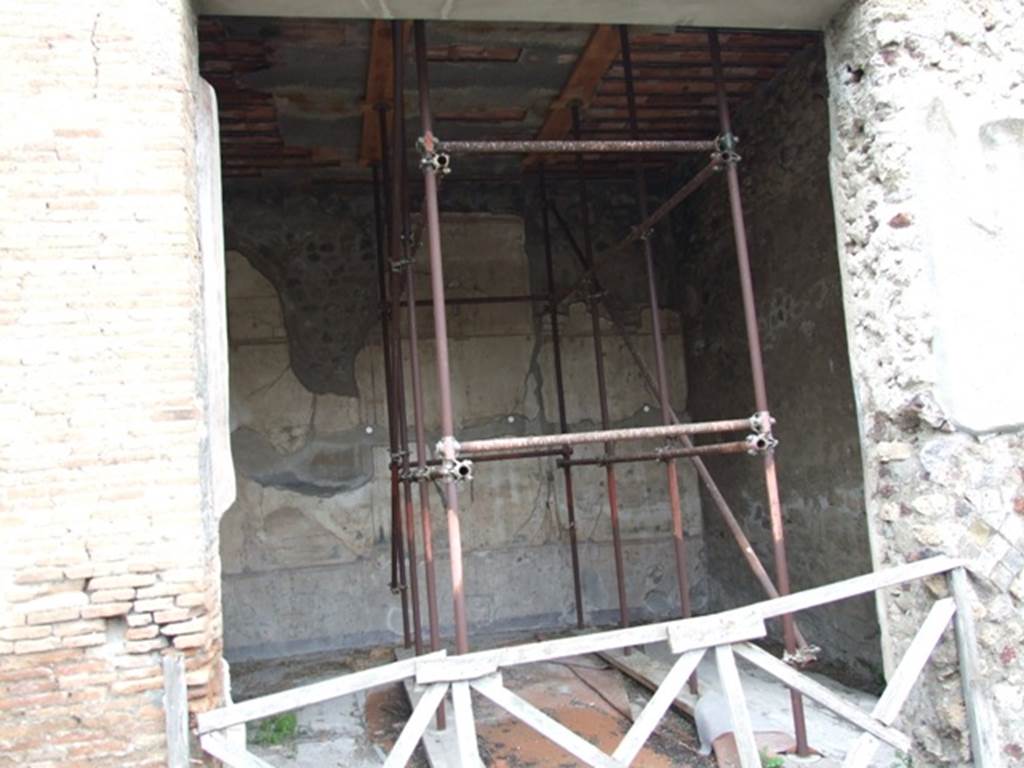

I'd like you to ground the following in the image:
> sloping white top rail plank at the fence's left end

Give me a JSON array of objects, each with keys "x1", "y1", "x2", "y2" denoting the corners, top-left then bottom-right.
[{"x1": 198, "y1": 650, "x2": 445, "y2": 733}]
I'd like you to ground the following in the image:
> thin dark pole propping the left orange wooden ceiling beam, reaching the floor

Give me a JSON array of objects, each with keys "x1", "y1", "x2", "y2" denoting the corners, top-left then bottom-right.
[{"x1": 374, "y1": 105, "x2": 413, "y2": 648}]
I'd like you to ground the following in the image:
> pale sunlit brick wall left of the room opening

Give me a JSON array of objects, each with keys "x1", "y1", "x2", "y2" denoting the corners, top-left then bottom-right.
[{"x1": 0, "y1": 0, "x2": 221, "y2": 766}]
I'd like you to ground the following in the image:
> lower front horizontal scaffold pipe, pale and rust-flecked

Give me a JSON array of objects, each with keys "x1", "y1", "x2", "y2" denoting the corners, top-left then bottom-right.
[{"x1": 457, "y1": 417, "x2": 758, "y2": 456}]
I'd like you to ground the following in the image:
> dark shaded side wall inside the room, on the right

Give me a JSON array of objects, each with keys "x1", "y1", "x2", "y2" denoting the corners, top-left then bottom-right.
[{"x1": 674, "y1": 45, "x2": 882, "y2": 687}]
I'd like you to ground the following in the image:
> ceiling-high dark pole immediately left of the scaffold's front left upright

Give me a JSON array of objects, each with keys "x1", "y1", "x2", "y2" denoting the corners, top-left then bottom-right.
[{"x1": 391, "y1": 22, "x2": 423, "y2": 655}]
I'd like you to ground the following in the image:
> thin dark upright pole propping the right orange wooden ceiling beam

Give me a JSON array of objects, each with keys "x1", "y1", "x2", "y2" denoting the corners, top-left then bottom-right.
[{"x1": 572, "y1": 104, "x2": 630, "y2": 627}]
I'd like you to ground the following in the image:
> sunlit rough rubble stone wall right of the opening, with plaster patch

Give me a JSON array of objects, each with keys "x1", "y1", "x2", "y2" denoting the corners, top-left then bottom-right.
[{"x1": 827, "y1": 0, "x2": 1024, "y2": 766}]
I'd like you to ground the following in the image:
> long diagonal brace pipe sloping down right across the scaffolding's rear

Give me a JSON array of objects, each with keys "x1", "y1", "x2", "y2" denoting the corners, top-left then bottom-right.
[{"x1": 549, "y1": 188, "x2": 814, "y2": 655}]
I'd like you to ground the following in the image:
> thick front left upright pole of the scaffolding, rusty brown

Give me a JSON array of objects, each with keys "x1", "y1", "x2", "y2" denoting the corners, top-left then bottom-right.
[{"x1": 413, "y1": 22, "x2": 469, "y2": 653}]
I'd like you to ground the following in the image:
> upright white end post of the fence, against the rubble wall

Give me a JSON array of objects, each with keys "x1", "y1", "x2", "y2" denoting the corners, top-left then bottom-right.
[{"x1": 949, "y1": 568, "x2": 1006, "y2": 768}]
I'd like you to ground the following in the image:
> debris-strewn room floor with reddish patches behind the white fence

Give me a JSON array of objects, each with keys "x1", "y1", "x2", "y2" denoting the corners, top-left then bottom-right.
[{"x1": 231, "y1": 636, "x2": 898, "y2": 768}]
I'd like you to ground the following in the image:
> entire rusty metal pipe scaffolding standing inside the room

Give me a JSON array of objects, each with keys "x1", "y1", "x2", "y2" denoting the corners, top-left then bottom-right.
[{"x1": 374, "y1": 22, "x2": 816, "y2": 755}]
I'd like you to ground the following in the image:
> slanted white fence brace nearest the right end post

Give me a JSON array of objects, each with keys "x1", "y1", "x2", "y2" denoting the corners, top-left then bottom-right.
[{"x1": 843, "y1": 597, "x2": 956, "y2": 768}]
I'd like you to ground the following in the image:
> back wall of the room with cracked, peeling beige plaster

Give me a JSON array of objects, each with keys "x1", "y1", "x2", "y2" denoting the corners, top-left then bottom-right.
[{"x1": 221, "y1": 183, "x2": 706, "y2": 656}]
